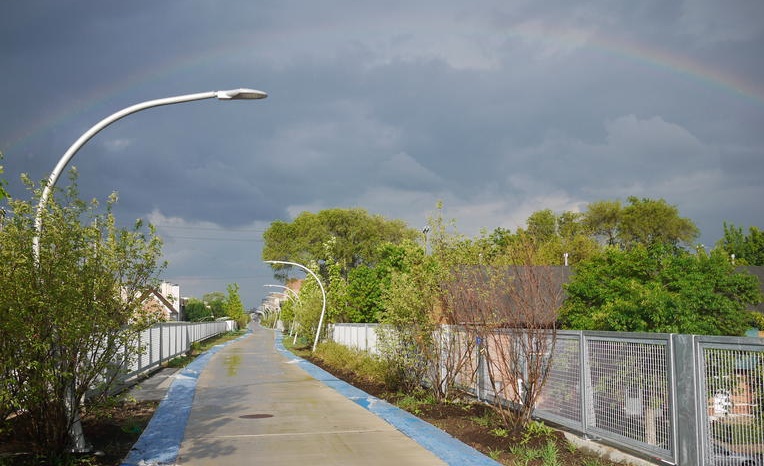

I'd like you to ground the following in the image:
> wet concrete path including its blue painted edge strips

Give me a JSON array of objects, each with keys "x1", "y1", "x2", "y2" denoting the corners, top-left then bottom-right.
[{"x1": 123, "y1": 326, "x2": 498, "y2": 466}]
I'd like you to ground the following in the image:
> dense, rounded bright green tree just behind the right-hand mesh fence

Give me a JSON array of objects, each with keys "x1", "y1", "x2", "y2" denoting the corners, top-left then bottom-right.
[{"x1": 560, "y1": 246, "x2": 761, "y2": 335}]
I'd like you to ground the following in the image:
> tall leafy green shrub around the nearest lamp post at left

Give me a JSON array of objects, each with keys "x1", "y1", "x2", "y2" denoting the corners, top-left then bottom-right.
[{"x1": 0, "y1": 172, "x2": 161, "y2": 457}]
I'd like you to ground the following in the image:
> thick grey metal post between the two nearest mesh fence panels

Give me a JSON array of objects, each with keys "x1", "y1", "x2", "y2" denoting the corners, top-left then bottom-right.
[{"x1": 669, "y1": 334, "x2": 706, "y2": 465}]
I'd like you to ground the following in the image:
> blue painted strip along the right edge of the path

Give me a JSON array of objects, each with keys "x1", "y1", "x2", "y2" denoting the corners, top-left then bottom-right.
[{"x1": 269, "y1": 329, "x2": 501, "y2": 466}]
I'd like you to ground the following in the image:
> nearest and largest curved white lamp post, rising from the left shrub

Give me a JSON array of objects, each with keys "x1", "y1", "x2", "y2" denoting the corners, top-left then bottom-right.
[{"x1": 32, "y1": 88, "x2": 268, "y2": 452}]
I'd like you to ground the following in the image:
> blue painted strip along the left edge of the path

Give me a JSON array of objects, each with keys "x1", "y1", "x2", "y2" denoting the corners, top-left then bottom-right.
[{"x1": 120, "y1": 329, "x2": 252, "y2": 466}]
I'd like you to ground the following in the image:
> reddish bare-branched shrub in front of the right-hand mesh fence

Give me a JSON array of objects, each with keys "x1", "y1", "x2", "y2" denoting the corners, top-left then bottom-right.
[{"x1": 454, "y1": 238, "x2": 565, "y2": 428}]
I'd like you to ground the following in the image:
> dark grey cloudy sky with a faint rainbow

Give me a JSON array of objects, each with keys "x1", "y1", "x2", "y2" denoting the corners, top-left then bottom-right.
[{"x1": 0, "y1": 0, "x2": 764, "y2": 307}]
